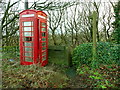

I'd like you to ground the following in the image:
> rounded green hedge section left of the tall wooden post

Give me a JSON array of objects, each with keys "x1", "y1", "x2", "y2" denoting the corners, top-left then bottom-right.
[{"x1": 73, "y1": 43, "x2": 92, "y2": 66}]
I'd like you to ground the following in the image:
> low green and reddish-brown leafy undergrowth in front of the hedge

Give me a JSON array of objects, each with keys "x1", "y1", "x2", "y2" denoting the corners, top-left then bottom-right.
[{"x1": 77, "y1": 65, "x2": 119, "y2": 88}]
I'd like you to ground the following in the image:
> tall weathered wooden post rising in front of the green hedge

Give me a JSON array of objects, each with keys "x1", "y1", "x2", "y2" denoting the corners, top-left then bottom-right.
[{"x1": 92, "y1": 11, "x2": 97, "y2": 66}]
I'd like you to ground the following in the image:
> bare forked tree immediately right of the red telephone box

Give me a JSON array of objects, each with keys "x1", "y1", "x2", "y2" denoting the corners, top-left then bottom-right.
[{"x1": 47, "y1": 2, "x2": 74, "y2": 45}]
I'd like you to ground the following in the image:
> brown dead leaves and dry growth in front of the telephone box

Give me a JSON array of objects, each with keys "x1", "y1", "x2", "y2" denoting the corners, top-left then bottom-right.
[{"x1": 2, "y1": 61, "x2": 67, "y2": 88}]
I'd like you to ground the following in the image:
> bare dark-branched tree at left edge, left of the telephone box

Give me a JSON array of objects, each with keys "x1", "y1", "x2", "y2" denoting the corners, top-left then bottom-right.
[{"x1": 0, "y1": 0, "x2": 18, "y2": 44}]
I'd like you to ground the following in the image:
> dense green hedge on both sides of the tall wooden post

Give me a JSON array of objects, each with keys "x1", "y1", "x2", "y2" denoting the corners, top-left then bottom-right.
[{"x1": 73, "y1": 42, "x2": 120, "y2": 67}]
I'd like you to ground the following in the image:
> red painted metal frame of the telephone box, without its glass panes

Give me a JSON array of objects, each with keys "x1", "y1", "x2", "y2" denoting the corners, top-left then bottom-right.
[{"x1": 19, "y1": 10, "x2": 48, "y2": 66}]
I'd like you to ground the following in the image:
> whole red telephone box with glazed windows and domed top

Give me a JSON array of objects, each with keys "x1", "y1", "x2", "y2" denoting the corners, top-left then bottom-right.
[{"x1": 19, "y1": 10, "x2": 48, "y2": 66}]
